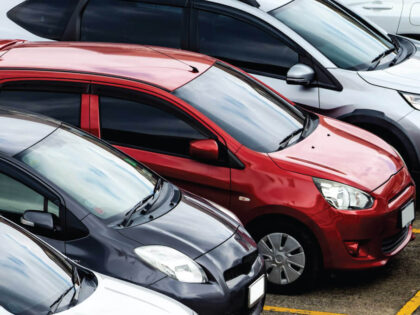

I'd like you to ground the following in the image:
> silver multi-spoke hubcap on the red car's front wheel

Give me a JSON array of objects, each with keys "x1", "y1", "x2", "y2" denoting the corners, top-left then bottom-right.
[{"x1": 258, "y1": 233, "x2": 306, "y2": 285}]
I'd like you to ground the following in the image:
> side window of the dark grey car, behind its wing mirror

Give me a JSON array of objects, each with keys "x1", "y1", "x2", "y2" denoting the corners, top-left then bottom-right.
[{"x1": 0, "y1": 160, "x2": 65, "y2": 253}]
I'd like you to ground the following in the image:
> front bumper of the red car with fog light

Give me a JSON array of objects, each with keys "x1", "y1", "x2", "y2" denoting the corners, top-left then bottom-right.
[{"x1": 324, "y1": 168, "x2": 415, "y2": 269}]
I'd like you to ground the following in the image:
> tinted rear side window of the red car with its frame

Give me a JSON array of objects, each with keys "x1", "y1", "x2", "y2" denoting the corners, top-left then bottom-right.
[{"x1": 0, "y1": 80, "x2": 89, "y2": 128}]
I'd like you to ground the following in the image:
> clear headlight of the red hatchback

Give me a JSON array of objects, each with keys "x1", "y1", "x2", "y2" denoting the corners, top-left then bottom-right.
[{"x1": 314, "y1": 178, "x2": 373, "y2": 210}]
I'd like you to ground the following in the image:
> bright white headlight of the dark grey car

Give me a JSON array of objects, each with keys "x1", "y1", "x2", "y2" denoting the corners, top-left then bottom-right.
[{"x1": 134, "y1": 245, "x2": 208, "y2": 283}]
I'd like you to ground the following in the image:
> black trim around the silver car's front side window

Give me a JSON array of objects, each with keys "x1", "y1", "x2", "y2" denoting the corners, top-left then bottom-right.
[{"x1": 189, "y1": 0, "x2": 343, "y2": 91}]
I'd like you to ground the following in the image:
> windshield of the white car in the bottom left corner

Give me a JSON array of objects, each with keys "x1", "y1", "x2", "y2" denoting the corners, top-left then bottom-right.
[{"x1": 0, "y1": 219, "x2": 73, "y2": 315}]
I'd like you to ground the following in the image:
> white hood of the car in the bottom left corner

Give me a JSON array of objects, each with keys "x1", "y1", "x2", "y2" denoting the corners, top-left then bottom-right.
[{"x1": 62, "y1": 273, "x2": 195, "y2": 315}]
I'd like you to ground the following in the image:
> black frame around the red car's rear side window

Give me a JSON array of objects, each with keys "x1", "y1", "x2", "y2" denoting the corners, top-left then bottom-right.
[{"x1": 0, "y1": 80, "x2": 90, "y2": 128}]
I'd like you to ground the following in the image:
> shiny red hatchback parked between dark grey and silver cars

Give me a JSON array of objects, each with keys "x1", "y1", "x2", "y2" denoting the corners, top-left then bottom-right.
[{"x1": 0, "y1": 41, "x2": 415, "y2": 291}]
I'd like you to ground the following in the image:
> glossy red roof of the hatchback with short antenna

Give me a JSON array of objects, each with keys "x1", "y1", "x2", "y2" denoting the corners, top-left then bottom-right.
[{"x1": 0, "y1": 40, "x2": 216, "y2": 91}]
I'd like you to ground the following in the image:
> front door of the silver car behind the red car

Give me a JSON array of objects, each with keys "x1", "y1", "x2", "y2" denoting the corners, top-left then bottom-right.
[{"x1": 190, "y1": 1, "x2": 319, "y2": 108}]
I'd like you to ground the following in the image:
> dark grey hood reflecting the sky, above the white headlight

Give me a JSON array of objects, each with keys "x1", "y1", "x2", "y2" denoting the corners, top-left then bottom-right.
[{"x1": 119, "y1": 191, "x2": 239, "y2": 259}]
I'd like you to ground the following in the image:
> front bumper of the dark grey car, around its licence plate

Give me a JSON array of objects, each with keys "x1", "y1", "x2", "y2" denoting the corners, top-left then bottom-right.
[{"x1": 150, "y1": 228, "x2": 265, "y2": 315}]
